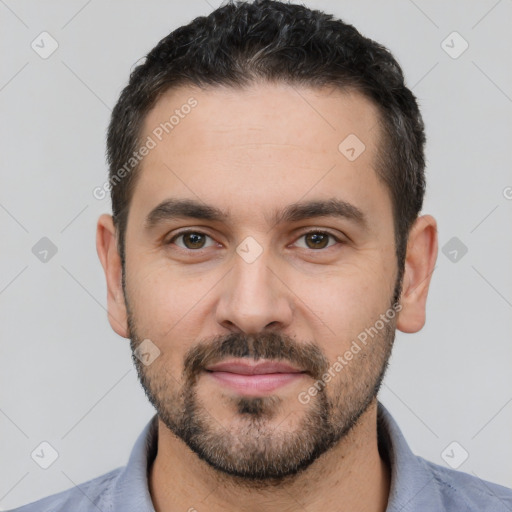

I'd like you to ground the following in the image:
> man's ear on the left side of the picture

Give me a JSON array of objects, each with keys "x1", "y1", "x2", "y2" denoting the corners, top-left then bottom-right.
[{"x1": 96, "y1": 213, "x2": 129, "y2": 338}]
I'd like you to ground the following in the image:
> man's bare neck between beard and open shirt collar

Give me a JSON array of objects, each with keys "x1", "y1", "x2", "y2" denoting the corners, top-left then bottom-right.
[{"x1": 149, "y1": 400, "x2": 390, "y2": 512}]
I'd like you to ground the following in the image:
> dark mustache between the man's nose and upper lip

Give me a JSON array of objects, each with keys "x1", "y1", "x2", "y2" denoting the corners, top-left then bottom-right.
[{"x1": 184, "y1": 332, "x2": 329, "y2": 382}]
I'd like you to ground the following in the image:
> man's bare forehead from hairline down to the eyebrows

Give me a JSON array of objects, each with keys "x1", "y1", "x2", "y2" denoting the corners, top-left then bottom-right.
[{"x1": 130, "y1": 83, "x2": 391, "y2": 234}]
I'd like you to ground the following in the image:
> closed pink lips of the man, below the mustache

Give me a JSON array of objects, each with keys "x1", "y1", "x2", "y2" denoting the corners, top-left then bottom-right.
[{"x1": 205, "y1": 359, "x2": 308, "y2": 396}]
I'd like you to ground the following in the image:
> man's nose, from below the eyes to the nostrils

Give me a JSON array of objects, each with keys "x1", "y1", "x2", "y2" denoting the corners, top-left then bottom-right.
[{"x1": 216, "y1": 251, "x2": 293, "y2": 334}]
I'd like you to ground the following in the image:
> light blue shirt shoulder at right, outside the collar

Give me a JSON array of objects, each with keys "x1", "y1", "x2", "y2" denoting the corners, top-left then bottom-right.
[{"x1": 418, "y1": 457, "x2": 512, "y2": 512}]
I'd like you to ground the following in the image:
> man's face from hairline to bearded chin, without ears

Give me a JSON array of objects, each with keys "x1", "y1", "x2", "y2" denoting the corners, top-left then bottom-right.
[{"x1": 121, "y1": 84, "x2": 398, "y2": 481}]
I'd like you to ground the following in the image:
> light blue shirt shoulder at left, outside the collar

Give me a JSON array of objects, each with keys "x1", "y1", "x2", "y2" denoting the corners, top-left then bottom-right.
[{"x1": 8, "y1": 467, "x2": 124, "y2": 512}]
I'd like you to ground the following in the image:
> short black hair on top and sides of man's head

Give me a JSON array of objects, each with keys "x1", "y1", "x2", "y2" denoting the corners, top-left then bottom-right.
[{"x1": 107, "y1": 0, "x2": 425, "y2": 300}]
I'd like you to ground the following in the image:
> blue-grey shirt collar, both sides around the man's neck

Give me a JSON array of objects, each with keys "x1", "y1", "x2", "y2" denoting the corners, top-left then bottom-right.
[{"x1": 112, "y1": 402, "x2": 442, "y2": 512}]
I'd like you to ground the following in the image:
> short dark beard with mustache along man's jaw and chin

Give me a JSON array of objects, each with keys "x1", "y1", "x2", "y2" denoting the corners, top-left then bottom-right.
[{"x1": 127, "y1": 302, "x2": 396, "y2": 489}]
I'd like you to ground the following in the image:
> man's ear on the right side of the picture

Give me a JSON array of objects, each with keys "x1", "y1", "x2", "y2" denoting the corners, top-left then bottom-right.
[{"x1": 396, "y1": 215, "x2": 438, "y2": 333}]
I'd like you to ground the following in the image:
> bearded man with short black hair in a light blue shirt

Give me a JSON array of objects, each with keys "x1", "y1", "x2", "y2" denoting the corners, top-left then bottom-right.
[{"x1": 9, "y1": 0, "x2": 512, "y2": 512}]
